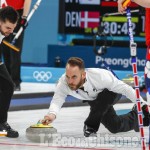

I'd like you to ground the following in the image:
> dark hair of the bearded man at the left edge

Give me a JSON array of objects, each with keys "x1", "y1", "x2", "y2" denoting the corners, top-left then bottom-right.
[{"x1": 0, "y1": 6, "x2": 19, "y2": 24}]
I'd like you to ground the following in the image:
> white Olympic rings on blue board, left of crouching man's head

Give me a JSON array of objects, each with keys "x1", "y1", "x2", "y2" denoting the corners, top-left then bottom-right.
[{"x1": 33, "y1": 71, "x2": 52, "y2": 82}]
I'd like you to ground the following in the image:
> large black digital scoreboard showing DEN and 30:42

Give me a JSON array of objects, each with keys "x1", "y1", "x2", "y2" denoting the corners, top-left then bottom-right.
[{"x1": 59, "y1": 0, "x2": 145, "y2": 37}]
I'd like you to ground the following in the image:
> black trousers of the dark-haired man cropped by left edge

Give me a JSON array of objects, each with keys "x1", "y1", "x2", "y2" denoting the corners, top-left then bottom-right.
[{"x1": 0, "y1": 64, "x2": 14, "y2": 123}]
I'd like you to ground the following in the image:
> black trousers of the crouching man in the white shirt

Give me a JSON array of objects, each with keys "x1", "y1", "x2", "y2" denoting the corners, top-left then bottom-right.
[{"x1": 84, "y1": 89, "x2": 138, "y2": 133}]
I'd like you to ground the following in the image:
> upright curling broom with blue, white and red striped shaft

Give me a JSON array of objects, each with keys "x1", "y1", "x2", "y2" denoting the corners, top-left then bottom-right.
[{"x1": 123, "y1": 0, "x2": 146, "y2": 150}]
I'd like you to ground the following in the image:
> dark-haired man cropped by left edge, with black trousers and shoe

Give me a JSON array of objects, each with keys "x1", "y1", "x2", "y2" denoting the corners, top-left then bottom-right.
[{"x1": 0, "y1": 6, "x2": 19, "y2": 137}]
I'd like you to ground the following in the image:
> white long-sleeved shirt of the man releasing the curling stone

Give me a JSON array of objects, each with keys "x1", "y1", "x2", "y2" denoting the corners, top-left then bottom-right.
[{"x1": 49, "y1": 68, "x2": 142, "y2": 115}]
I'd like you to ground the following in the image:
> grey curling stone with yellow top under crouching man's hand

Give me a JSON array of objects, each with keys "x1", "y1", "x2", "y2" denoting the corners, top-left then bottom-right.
[{"x1": 26, "y1": 124, "x2": 57, "y2": 143}]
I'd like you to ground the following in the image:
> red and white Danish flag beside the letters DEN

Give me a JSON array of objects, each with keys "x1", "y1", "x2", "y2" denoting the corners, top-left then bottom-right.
[{"x1": 80, "y1": 11, "x2": 100, "y2": 28}]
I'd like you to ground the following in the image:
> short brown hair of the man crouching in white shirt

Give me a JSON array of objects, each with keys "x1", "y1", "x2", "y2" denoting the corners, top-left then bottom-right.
[{"x1": 67, "y1": 57, "x2": 85, "y2": 70}]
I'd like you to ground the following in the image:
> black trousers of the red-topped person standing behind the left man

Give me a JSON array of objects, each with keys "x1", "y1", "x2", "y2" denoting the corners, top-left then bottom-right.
[{"x1": 1, "y1": 10, "x2": 24, "y2": 86}]
